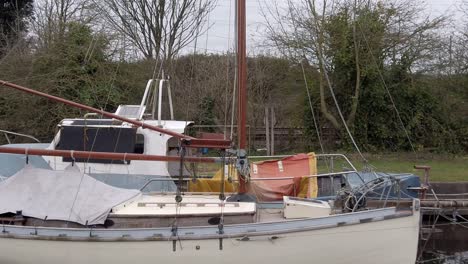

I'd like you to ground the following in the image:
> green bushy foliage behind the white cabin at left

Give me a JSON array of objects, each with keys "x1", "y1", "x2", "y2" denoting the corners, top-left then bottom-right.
[{"x1": 2, "y1": 22, "x2": 124, "y2": 139}]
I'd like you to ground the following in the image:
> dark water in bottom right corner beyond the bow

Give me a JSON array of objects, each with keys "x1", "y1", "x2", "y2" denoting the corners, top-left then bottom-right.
[{"x1": 417, "y1": 222, "x2": 468, "y2": 264}]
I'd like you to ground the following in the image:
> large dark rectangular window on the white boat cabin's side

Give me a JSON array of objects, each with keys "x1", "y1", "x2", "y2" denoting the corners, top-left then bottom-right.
[{"x1": 55, "y1": 126, "x2": 145, "y2": 164}]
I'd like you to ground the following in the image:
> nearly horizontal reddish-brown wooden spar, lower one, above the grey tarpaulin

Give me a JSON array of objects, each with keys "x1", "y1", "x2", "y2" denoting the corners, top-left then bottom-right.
[{"x1": 0, "y1": 147, "x2": 221, "y2": 163}]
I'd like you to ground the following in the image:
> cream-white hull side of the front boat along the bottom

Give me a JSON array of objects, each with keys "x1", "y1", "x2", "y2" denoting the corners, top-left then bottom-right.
[{"x1": 0, "y1": 212, "x2": 420, "y2": 264}]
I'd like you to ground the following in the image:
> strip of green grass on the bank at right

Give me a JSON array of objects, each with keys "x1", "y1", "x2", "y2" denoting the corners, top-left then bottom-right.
[{"x1": 352, "y1": 153, "x2": 468, "y2": 182}]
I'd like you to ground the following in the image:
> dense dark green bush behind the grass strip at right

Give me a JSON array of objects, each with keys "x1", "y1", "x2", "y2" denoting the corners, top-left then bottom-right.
[{"x1": 355, "y1": 77, "x2": 456, "y2": 151}]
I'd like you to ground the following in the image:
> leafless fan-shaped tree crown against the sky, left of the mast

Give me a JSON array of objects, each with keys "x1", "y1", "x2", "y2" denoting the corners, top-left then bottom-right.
[{"x1": 95, "y1": 0, "x2": 216, "y2": 60}]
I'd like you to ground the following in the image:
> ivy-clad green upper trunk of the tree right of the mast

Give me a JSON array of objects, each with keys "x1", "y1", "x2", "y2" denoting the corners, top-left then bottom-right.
[{"x1": 324, "y1": 4, "x2": 386, "y2": 119}]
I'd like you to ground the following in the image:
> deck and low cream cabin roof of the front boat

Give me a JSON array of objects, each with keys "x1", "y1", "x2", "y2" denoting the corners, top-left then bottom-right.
[{"x1": 4, "y1": 194, "x2": 410, "y2": 229}]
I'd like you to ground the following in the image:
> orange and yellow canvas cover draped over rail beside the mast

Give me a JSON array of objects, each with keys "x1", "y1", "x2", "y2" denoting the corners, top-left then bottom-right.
[{"x1": 248, "y1": 153, "x2": 317, "y2": 201}]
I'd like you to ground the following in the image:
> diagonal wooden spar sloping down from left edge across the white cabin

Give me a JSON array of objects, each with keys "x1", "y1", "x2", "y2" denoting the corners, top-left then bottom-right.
[{"x1": 0, "y1": 80, "x2": 231, "y2": 149}]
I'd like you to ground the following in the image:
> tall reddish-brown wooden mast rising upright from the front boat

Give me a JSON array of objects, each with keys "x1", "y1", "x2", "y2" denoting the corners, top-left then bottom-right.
[{"x1": 236, "y1": 0, "x2": 247, "y2": 194}]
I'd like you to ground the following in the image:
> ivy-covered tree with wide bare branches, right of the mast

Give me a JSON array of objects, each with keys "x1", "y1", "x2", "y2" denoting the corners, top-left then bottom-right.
[{"x1": 263, "y1": 0, "x2": 445, "y2": 129}]
